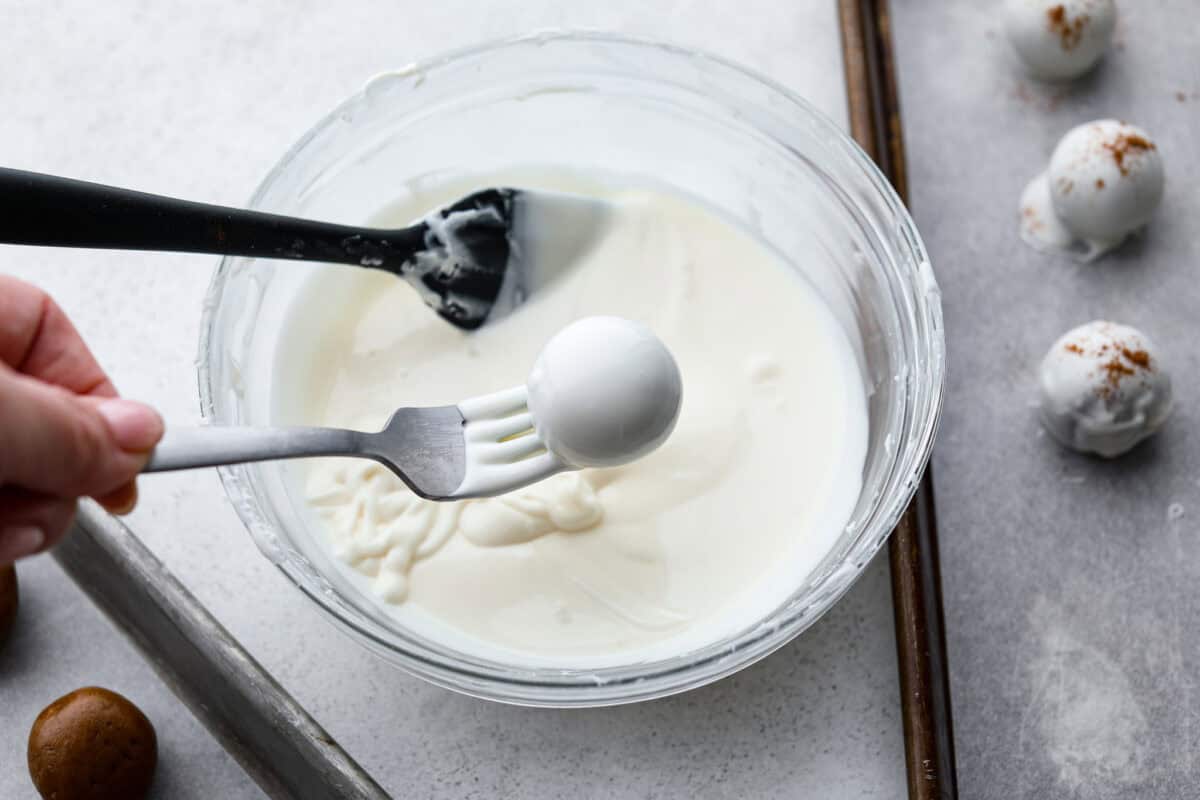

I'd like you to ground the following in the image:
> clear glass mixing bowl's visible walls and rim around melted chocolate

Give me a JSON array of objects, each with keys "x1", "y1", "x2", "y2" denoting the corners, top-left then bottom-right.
[{"x1": 199, "y1": 34, "x2": 944, "y2": 706}]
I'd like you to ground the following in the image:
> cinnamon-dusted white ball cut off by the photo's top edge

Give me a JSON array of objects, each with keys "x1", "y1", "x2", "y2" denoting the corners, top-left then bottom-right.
[{"x1": 1004, "y1": 0, "x2": 1117, "y2": 80}]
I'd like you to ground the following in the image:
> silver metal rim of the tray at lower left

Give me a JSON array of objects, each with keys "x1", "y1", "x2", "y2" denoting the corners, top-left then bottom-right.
[{"x1": 54, "y1": 504, "x2": 388, "y2": 800}]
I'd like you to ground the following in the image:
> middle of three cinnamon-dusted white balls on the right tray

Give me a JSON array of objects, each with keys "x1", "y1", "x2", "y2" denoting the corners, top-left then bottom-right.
[{"x1": 1048, "y1": 120, "x2": 1165, "y2": 248}]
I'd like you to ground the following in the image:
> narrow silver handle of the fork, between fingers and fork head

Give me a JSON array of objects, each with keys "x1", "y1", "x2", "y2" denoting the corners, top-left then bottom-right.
[{"x1": 142, "y1": 426, "x2": 371, "y2": 473}]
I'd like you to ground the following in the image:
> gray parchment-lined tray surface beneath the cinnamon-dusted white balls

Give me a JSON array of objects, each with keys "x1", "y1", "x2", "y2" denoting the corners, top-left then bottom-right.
[{"x1": 894, "y1": 0, "x2": 1200, "y2": 800}]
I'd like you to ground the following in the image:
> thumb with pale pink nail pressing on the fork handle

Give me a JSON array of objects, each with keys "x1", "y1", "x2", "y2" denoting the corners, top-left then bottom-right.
[{"x1": 0, "y1": 368, "x2": 163, "y2": 498}]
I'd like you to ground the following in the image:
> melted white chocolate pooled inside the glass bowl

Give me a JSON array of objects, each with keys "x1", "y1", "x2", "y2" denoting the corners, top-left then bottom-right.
[{"x1": 275, "y1": 169, "x2": 868, "y2": 668}]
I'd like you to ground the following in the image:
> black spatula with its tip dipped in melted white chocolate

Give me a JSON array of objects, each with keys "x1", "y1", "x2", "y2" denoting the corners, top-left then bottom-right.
[{"x1": 0, "y1": 168, "x2": 607, "y2": 330}]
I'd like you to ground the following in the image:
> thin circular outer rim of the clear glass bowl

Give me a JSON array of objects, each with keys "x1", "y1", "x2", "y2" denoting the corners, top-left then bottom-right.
[{"x1": 197, "y1": 30, "x2": 946, "y2": 708}]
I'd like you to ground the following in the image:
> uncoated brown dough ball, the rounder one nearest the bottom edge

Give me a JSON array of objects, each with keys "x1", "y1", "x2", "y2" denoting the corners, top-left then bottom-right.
[{"x1": 29, "y1": 686, "x2": 158, "y2": 800}]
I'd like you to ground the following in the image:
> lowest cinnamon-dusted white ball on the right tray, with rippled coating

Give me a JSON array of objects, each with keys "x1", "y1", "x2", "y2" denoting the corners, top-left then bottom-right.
[{"x1": 1040, "y1": 321, "x2": 1171, "y2": 458}]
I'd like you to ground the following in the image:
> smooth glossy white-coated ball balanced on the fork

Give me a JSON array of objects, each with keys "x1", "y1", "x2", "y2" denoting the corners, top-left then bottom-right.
[{"x1": 526, "y1": 317, "x2": 683, "y2": 467}]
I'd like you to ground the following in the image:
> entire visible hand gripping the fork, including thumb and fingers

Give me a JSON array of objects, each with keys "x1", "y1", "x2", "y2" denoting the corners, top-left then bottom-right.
[{"x1": 0, "y1": 276, "x2": 163, "y2": 564}]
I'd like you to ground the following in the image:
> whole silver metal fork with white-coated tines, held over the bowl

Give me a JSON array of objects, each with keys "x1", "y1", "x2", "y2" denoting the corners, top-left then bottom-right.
[{"x1": 143, "y1": 386, "x2": 574, "y2": 500}]
